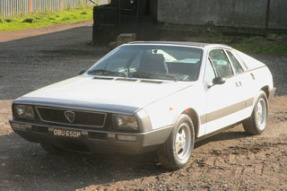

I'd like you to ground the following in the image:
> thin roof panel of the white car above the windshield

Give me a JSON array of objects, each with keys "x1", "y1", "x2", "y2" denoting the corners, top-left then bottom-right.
[{"x1": 128, "y1": 41, "x2": 231, "y2": 48}]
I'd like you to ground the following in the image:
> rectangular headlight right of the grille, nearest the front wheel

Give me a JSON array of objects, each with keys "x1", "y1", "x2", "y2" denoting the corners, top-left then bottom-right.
[{"x1": 113, "y1": 115, "x2": 139, "y2": 131}]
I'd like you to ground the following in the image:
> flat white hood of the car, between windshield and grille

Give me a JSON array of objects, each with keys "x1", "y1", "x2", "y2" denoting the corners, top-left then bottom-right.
[{"x1": 19, "y1": 76, "x2": 192, "y2": 112}]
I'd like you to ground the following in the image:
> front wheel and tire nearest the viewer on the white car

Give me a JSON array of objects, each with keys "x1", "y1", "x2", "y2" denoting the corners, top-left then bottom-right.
[{"x1": 158, "y1": 114, "x2": 195, "y2": 170}]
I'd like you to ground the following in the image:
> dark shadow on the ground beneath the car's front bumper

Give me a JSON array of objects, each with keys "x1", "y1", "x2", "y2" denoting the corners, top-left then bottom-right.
[{"x1": 0, "y1": 133, "x2": 168, "y2": 190}]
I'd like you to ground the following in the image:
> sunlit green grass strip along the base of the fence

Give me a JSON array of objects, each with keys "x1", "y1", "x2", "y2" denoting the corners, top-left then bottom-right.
[{"x1": 0, "y1": 8, "x2": 93, "y2": 31}]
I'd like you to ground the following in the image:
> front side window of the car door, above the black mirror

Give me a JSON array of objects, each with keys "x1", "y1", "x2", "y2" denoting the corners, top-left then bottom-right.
[{"x1": 209, "y1": 49, "x2": 233, "y2": 78}]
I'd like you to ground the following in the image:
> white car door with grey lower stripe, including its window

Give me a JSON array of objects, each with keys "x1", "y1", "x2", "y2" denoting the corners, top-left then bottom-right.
[{"x1": 202, "y1": 49, "x2": 243, "y2": 134}]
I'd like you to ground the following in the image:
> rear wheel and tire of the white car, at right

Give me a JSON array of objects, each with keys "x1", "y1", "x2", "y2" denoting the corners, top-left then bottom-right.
[{"x1": 243, "y1": 91, "x2": 268, "y2": 135}]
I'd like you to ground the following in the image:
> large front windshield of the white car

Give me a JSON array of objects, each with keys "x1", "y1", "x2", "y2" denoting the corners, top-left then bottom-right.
[{"x1": 88, "y1": 45, "x2": 203, "y2": 81}]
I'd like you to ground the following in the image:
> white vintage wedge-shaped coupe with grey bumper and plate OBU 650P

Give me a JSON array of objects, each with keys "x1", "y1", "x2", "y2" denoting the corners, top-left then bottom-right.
[{"x1": 10, "y1": 42, "x2": 275, "y2": 169}]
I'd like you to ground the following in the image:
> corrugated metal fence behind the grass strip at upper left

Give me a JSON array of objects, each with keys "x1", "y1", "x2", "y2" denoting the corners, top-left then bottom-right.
[{"x1": 0, "y1": 0, "x2": 109, "y2": 18}]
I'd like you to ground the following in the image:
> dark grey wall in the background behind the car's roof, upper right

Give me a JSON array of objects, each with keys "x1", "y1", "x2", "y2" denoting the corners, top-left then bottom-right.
[{"x1": 157, "y1": 0, "x2": 287, "y2": 30}]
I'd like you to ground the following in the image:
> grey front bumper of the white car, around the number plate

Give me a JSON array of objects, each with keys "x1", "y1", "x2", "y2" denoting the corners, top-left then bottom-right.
[{"x1": 9, "y1": 120, "x2": 173, "y2": 154}]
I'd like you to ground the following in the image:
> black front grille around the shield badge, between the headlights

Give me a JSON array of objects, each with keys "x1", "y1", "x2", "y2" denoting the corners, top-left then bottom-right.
[{"x1": 36, "y1": 107, "x2": 106, "y2": 128}]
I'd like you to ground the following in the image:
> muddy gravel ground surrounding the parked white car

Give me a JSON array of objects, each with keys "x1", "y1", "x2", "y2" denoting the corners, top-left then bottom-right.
[{"x1": 0, "y1": 22, "x2": 287, "y2": 191}]
